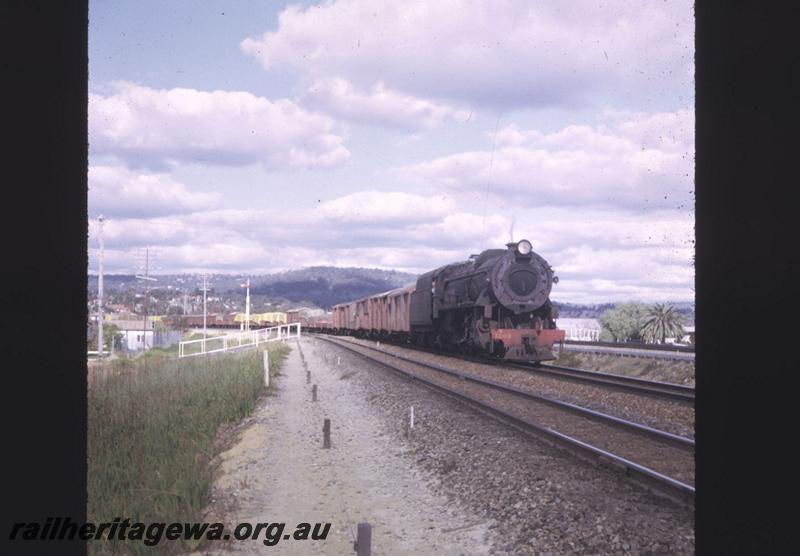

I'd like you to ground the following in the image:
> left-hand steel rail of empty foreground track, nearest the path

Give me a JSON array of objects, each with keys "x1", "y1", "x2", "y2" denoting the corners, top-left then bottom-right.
[{"x1": 317, "y1": 335, "x2": 695, "y2": 505}]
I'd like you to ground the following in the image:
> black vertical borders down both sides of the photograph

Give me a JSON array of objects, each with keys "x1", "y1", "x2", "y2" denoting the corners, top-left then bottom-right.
[{"x1": 0, "y1": 0, "x2": 800, "y2": 554}]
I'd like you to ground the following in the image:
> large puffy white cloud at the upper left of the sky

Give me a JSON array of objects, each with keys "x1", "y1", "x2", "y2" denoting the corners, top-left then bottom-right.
[{"x1": 89, "y1": 82, "x2": 350, "y2": 167}]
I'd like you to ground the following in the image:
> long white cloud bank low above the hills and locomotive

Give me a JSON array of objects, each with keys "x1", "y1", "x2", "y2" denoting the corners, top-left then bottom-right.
[{"x1": 90, "y1": 191, "x2": 694, "y2": 302}]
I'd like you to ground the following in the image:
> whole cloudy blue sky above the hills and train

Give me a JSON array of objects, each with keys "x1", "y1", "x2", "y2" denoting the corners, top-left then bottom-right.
[{"x1": 88, "y1": 0, "x2": 694, "y2": 303}]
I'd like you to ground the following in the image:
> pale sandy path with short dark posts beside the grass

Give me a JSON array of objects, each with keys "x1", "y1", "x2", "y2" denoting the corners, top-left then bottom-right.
[{"x1": 203, "y1": 338, "x2": 498, "y2": 555}]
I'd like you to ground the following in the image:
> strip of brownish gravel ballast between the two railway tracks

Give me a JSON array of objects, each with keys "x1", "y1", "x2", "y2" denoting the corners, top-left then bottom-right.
[{"x1": 343, "y1": 337, "x2": 694, "y2": 438}]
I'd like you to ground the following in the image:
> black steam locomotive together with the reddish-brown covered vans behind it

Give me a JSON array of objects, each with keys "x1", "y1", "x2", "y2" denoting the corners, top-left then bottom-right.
[{"x1": 312, "y1": 240, "x2": 565, "y2": 361}]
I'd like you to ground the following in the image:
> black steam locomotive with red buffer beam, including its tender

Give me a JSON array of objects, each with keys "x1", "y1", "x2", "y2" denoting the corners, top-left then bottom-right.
[{"x1": 409, "y1": 240, "x2": 564, "y2": 361}]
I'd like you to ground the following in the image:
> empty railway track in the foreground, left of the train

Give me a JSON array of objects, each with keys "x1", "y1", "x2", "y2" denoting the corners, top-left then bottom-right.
[{"x1": 318, "y1": 336, "x2": 694, "y2": 504}]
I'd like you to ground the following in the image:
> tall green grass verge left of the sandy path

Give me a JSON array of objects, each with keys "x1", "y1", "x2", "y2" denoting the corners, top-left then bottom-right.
[{"x1": 87, "y1": 343, "x2": 289, "y2": 554}]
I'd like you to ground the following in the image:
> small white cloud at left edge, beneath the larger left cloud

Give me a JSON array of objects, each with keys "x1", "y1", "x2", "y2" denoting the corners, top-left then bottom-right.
[{"x1": 88, "y1": 166, "x2": 221, "y2": 218}]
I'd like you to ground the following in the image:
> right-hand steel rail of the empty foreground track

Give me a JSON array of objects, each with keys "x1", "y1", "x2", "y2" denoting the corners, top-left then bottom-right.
[{"x1": 337, "y1": 339, "x2": 695, "y2": 452}]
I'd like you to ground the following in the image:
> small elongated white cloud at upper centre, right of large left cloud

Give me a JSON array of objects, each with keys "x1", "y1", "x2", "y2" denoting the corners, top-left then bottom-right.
[{"x1": 300, "y1": 78, "x2": 470, "y2": 129}]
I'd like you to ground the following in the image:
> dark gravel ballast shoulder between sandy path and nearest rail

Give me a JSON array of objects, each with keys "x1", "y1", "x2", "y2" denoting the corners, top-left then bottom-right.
[{"x1": 316, "y1": 340, "x2": 694, "y2": 554}]
